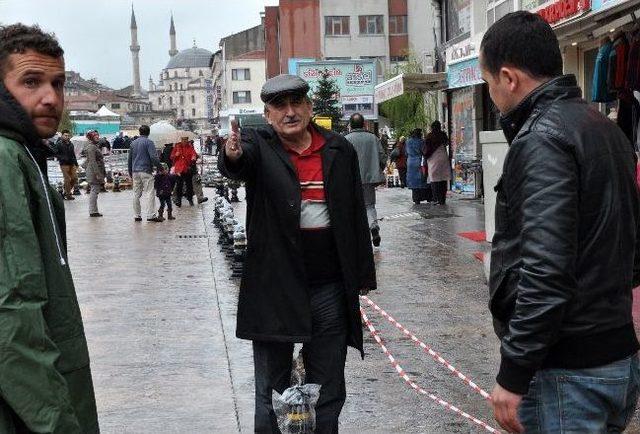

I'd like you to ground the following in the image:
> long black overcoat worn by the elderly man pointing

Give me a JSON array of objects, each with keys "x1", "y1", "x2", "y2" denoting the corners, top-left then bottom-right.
[{"x1": 218, "y1": 125, "x2": 376, "y2": 354}]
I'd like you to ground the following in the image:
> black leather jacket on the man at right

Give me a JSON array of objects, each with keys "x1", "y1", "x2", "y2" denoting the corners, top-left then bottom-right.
[{"x1": 489, "y1": 75, "x2": 640, "y2": 394}]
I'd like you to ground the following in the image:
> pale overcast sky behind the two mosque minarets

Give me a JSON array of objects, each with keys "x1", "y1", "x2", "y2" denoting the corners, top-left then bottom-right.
[{"x1": 0, "y1": 0, "x2": 278, "y2": 89}]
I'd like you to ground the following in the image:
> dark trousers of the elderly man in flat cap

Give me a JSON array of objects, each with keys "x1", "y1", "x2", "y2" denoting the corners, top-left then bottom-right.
[{"x1": 253, "y1": 283, "x2": 348, "y2": 433}]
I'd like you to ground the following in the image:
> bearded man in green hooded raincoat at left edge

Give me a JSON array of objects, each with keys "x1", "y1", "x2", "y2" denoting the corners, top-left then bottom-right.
[{"x1": 0, "y1": 24, "x2": 99, "y2": 434}]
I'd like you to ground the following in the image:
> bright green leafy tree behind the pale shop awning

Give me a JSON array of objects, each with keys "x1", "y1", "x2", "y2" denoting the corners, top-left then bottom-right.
[{"x1": 380, "y1": 55, "x2": 438, "y2": 137}]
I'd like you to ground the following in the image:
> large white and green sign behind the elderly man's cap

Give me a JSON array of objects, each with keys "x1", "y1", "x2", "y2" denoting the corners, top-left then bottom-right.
[{"x1": 297, "y1": 60, "x2": 377, "y2": 119}]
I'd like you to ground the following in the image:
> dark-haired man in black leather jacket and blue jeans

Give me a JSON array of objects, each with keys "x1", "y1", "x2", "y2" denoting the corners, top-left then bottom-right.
[{"x1": 480, "y1": 12, "x2": 640, "y2": 432}]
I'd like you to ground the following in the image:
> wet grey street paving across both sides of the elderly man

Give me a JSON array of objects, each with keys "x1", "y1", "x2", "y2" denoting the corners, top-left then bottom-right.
[{"x1": 61, "y1": 188, "x2": 637, "y2": 433}]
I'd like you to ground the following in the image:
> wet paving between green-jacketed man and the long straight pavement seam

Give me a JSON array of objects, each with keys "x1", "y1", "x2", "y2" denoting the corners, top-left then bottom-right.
[{"x1": 65, "y1": 191, "x2": 238, "y2": 434}]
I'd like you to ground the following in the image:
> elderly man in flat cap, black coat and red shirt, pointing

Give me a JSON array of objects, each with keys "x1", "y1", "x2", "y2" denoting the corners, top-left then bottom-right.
[{"x1": 218, "y1": 75, "x2": 376, "y2": 433}]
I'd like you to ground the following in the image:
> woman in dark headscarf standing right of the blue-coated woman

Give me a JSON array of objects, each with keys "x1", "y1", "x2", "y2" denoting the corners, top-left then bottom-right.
[{"x1": 422, "y1": 121, "x2": 451, "y2": 205}]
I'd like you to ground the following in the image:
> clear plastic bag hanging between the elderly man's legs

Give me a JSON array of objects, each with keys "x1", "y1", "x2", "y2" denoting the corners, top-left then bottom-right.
[{"x1": 272, "y1": 384, "x2": 322, "y2": 434}]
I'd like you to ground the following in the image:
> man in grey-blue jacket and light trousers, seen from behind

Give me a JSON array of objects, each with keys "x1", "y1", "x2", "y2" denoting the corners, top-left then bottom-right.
[{"x1": 128, "y1": 125, "x2": 161, "y2": 222}]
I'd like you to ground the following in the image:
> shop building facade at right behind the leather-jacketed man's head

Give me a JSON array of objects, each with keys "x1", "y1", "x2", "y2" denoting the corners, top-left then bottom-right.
[{"x1": 440, "y1": 0, "x2": 640, "y2": 194}]
